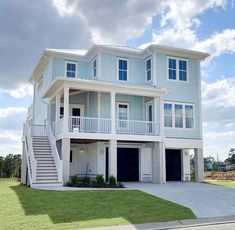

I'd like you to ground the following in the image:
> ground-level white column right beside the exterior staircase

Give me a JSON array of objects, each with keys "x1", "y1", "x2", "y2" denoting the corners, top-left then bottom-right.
[{"x1": 61, "y1": 138, "x2": 70, "y2": 185}]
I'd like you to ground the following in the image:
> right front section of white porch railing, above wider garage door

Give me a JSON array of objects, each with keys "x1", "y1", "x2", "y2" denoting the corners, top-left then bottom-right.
[{"x1": 116, "y1": 120, "x2": 160, "y2": 136}]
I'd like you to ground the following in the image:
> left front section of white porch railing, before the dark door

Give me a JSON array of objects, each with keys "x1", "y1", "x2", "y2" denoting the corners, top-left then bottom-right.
[{"x1": 69, "y1": 116, "x2": 111, "y2": 133}]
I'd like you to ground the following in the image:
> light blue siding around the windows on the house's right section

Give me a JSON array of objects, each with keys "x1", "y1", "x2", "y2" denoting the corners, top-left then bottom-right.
[{"x1": 156, "y1": 54, "x2": 200, "y2": 138}]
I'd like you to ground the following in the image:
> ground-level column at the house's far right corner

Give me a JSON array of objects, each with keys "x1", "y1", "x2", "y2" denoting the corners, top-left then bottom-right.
[{"x1": 194, "y1": 148, "x2": 204, "y2": 182}]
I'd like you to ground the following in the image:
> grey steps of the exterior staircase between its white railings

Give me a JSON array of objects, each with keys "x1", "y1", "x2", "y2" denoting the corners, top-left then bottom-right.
[{"x1": 32, "y1": 136, "x2": 61, "y2": 185}]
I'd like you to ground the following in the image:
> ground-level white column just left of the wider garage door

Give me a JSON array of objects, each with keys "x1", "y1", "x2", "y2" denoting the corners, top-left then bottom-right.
[{"x1": 109, "y1": 140, "x2": 117, "y2": 178}]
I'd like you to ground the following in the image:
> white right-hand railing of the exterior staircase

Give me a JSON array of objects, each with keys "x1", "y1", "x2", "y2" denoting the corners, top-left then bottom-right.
[{"x1": 47, "y1": 125, "x2": 63, "y2": 182}]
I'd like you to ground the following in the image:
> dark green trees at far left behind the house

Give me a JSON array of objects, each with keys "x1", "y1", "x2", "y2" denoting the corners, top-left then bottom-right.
[{"x1": 0, "y1": 154, "x2": 21, "y2": 178}]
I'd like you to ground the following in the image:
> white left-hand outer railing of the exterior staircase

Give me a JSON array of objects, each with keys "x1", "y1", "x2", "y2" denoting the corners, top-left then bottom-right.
[{"x1": 25, "y1": 122, "x2": 37, "y2": 184}]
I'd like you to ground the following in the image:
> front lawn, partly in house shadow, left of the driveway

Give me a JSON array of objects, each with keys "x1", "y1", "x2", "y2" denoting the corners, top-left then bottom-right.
[{"x1": 0, "y1": 179, "x2": 195, "y2": 229}]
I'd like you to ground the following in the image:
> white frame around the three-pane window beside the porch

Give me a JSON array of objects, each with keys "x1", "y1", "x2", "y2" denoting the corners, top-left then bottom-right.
[{"x1": 163, "y1": 101, "x2": 196, "y2": 130}]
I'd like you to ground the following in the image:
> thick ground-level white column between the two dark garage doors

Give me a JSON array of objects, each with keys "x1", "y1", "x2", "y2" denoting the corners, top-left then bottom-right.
[{"x1": 152, "y1": 142, "x2": 166, "y2": 184}]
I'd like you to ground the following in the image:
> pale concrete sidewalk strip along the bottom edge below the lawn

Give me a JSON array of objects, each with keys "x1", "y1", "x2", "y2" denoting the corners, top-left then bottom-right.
[{"x1": 86, "y1": 216, "x2": 235, "y2": 230}]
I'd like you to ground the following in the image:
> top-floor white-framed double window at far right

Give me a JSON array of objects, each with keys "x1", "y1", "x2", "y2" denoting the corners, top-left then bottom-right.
[{"x1": 167, "y1": 57, "x2": 188, "y2": 82}]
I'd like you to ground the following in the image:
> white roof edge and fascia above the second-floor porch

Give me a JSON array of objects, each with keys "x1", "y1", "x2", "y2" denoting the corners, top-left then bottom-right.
[{"x1": 43, "y1": 77, "x2": 167, "y2": 100}]
